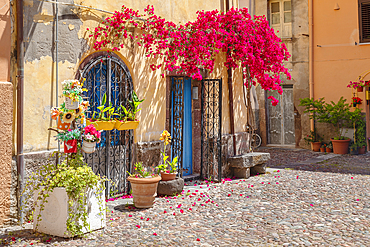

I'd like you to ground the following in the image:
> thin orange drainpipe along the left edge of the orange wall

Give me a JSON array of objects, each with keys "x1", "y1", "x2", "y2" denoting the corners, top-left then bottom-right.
[{"x1": 308, "y1": 0, "x2": 315, "y2": 131}]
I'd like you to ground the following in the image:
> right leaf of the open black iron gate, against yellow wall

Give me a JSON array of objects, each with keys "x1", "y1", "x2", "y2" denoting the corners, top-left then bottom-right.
[{"x1": 200, "y1": 79, "x2": 222, "y2": 181}]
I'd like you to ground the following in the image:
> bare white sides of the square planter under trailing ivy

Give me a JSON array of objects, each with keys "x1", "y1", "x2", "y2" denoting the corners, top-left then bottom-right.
[{"x1": 33, "y1": 187, "x2": 106, "y2": 238}]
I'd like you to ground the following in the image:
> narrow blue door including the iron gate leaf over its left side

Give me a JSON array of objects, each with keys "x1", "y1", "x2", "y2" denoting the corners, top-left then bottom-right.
[{"x1": 171, "y1": 77, "x2": 193, "y2": 176}]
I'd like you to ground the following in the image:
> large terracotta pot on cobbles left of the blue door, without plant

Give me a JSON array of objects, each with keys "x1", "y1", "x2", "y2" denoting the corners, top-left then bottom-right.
[{"x1": 127, "y1": 176, "x2": 161, "y2": 208}]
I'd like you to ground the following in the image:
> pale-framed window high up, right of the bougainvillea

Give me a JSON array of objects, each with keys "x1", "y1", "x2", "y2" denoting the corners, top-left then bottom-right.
[{"x1": 269, "y1": 0, "x2": 292, "y2": 38}]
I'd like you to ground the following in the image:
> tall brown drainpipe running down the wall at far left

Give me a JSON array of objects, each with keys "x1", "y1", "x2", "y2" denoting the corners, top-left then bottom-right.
[{"x1": 17, "y1": 0, "x2": 24, "y2": 223}]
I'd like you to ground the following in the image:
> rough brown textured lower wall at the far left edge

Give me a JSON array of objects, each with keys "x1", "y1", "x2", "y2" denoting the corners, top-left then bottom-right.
[{"x1": 0, "y1": 82, "x2": 13, "y2": 226}]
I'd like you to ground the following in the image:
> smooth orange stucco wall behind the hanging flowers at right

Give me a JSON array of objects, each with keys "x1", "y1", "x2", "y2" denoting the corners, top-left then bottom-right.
[{"x1": 313, "y1": 0, "x2": 370, "y2": 109}]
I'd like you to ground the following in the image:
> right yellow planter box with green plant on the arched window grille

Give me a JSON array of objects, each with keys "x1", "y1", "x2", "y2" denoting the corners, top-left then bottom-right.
[{"x1": 114, "y1": 91, "x2": 144, "y2": 130}]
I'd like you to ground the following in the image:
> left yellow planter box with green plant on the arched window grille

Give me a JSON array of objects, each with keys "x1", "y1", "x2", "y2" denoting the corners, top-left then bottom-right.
[{"x1": 86, "y1": 93, "x2": 116, "y2": 130}]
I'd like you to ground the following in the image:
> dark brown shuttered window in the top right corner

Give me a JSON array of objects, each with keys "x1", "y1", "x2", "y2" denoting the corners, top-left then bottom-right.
[{"x1": 358, "y1": 0, "x2": 370, "y2": 43}]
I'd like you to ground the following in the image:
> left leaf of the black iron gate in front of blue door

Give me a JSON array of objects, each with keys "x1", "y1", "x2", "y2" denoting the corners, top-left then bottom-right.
[{"x1": 171, "y1": 77, "x2": 184, "y2": 177}]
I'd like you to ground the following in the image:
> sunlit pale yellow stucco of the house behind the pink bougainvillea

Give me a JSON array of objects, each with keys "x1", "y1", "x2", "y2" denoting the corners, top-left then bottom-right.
[{"x1": 24, "y1": 0, "x2": 251, "y2": 152}]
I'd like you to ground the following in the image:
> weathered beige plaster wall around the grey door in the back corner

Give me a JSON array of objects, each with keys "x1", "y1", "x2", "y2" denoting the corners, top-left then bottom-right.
[{"x1": 255, "y1": 0, "x2": 310, "y2": 146}]
